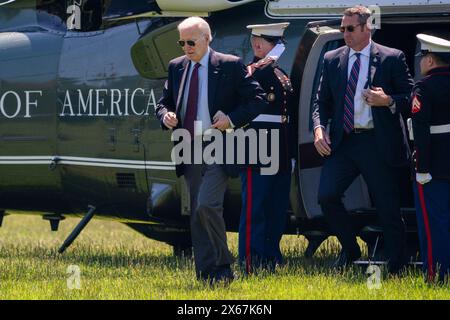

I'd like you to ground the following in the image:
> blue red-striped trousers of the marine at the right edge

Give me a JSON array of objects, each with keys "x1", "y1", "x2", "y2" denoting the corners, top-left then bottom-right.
[{"x1": 414, "y1": 179, "x2": 450, "y2": 280}]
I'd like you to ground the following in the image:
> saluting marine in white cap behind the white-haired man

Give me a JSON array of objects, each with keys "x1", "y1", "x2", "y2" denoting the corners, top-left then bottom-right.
[{"x1": 239, "y1": 23, "x2": 294, "y2": 273}]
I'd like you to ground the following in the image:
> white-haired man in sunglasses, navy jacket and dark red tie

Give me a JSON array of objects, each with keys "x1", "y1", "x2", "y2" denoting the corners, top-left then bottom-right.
[{"x1": 156, "y1": 17, "x2": 267, "y2": 282}]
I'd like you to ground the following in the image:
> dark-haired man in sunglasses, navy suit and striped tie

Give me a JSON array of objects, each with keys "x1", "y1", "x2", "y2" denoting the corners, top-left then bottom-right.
[{"x1": 313, "y1": 6, "x2": 413, "y2": 273}]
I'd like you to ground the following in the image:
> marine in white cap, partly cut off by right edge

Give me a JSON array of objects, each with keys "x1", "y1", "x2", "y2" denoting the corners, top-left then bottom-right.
[{"x1": 408, "y1": 34, "x2": 450, "y2": 281}]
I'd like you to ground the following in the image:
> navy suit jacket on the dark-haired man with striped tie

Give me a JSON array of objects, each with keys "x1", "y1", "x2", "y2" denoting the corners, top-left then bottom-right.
[{"x1": 312, "y1": 41, "x2": 414, "y2": 166}]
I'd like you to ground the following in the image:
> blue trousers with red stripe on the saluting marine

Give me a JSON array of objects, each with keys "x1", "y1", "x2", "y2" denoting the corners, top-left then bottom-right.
[{"x1": 239, "y1": 168, "x2": 291, "y2": 272}]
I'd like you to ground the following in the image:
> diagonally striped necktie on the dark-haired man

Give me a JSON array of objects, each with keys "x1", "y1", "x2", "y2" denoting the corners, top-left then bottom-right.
[{"x1": 344, "y1": 53, "x2": 361, "y2": 133}]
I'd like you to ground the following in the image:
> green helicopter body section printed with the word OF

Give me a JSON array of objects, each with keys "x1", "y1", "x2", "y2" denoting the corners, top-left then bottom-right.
[{"x1": 0, "y1": 29, "x2": 62, "y2": 210}]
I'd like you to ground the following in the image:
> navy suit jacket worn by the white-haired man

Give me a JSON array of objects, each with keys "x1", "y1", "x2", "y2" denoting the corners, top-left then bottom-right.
[{"x1": 156, "y1": 49, "x2": 267, "y2": 176}]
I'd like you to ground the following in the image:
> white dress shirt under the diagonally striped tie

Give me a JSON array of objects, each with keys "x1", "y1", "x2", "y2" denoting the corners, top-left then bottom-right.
[{"x1": 347, "y1": 41, "x2": 373, "y2": 129}]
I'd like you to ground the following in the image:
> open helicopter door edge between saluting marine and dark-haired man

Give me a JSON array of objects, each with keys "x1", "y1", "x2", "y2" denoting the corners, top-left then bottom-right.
[{"x1": 298, "y1": 21, "x2": 371, "y2": 218}]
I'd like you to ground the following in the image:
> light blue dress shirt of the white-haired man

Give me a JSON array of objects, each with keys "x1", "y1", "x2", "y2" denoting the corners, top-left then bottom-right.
[{"x1": 181, "y1": 48, "x2": 211, "y2": 135}]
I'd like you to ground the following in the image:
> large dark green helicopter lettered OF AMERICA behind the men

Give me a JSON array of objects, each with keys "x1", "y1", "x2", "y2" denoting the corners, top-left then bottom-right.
[{"x1": 0, "y1": 0, "x2": 450, "y2": 258}]
